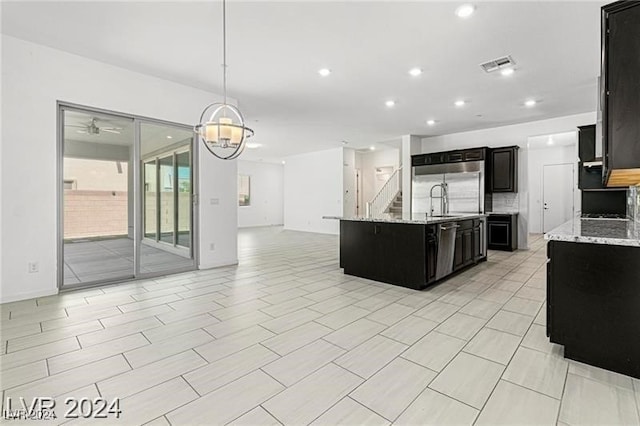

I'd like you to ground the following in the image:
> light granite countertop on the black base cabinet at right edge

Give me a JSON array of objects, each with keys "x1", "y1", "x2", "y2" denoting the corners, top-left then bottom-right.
[{"x1": 544, "y1": 217, "x2": 640, "y2": 247}]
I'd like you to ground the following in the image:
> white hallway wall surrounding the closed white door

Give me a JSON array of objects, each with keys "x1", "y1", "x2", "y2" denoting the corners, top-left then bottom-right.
[{"x1": 528, "y1": 143, "x2": 580, "y2": 234}]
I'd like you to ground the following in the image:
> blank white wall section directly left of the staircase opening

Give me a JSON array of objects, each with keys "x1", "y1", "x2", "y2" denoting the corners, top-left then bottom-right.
[{"x1": 284, "y1": 148, "x2": 344, "y2": 234}]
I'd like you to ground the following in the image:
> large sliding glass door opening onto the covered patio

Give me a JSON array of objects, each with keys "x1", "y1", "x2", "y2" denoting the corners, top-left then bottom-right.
[{"x1": 58, "y1": 105, "x2": 196, "y2": 287}]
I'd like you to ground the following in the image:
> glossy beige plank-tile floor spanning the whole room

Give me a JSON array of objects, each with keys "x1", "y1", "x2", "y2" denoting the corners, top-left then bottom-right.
[{"x1": 0, "y1": 228, "x2": 640, "y2": 425}]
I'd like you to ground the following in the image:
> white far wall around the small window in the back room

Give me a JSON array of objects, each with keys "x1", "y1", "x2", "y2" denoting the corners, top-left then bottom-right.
[{"x1": 238, "y1": 161, "x2": 284, "y2": 228}]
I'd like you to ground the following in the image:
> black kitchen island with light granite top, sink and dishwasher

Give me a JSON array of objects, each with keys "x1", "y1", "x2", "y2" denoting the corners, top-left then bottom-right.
[{"x1": 332, "y1": 214, "x2": 487, "y2": 290}]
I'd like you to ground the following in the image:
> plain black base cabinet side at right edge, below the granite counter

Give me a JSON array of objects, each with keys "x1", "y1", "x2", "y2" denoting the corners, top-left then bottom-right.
[{"x1": 547, "y1": 241, "x2": 640, "y2": 378}]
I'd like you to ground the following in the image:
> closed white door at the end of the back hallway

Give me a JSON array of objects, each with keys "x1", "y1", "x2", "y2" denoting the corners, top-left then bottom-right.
[{"x1": 542, "y1": 163, "x2": 574, "y2": 232}]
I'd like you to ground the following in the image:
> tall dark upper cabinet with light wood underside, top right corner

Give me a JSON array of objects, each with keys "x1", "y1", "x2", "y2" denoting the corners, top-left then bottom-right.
[{"x1": 601, "y1": 1, "x2": 640, "y2": 186}]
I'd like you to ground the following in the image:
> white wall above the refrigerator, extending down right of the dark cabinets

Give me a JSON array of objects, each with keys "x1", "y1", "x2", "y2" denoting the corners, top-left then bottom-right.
[{"x1": 422, "y1": 112, "x2": 596, "y2": 248}]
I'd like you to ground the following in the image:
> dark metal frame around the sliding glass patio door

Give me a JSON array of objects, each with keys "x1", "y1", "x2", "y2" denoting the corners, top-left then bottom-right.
[{"x1": 56, "y1": 100, "x2": 200, "y2": 291}]
